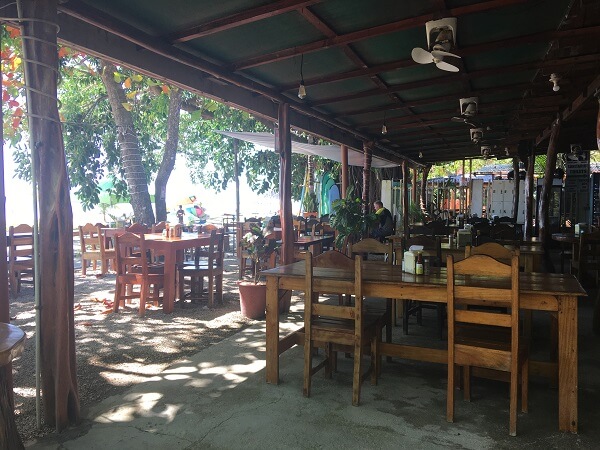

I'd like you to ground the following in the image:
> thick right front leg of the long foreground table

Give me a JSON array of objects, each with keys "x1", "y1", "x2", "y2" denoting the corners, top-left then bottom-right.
[{"x1": 558, "y1": 297, "x2": 577, "y2": 433}]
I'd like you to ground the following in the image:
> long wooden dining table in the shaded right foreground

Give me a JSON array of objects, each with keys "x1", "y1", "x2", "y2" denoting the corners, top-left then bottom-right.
[{"x1": 262, "y1": 261, "x2": 587, "y2": 433}]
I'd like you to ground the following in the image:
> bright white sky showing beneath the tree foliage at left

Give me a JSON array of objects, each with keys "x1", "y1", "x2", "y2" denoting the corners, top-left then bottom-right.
[{"x1": 4, "y1": 147, "x2": 286, "y2": 226}]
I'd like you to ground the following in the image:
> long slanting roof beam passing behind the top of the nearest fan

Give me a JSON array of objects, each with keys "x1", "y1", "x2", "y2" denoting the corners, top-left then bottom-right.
[{"x1": 231, "y1": 0, "x2": 527, "y2": 71}]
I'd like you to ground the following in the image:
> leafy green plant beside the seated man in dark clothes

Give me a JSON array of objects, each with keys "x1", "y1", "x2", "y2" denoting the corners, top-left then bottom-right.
[{"x1": 329, "y1": 189, "x2": 377, "y2": 253}]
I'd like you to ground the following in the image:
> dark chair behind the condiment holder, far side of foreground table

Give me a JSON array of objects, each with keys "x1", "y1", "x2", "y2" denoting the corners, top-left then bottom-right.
[{"x1": 401, "y1": 235, "x2": 446, "y2": 339}]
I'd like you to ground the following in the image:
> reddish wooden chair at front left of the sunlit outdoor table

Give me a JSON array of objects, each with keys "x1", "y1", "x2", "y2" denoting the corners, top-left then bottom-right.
[{"x1": 113, "y1": 231, "x2": 164, "y2": 316}]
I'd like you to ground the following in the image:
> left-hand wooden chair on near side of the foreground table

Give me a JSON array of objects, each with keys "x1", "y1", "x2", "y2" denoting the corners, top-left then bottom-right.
[{"x1": 303, "y1": 252, "x2": 380, "y2": 406}]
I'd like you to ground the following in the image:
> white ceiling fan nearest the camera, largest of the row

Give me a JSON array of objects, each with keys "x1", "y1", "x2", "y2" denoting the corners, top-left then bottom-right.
[{"x1": 411, "y1": 17, "x2": 460, "y2": 72}]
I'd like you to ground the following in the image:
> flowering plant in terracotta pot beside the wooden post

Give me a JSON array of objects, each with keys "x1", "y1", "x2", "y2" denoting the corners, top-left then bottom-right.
[{"x1": 238, "y1": 223, "x2": 278, "y2": 319}]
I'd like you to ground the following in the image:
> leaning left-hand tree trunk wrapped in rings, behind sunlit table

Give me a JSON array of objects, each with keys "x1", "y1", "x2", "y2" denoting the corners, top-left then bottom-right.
[{"x1": 100, "y1": 60, "x2": 154, "y2": 225}]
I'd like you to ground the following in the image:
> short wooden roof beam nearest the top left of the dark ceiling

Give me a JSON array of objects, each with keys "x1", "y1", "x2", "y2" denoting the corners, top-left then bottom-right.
[{"x1": 167, "y1": 0, "x2": 323, "y2": 43}]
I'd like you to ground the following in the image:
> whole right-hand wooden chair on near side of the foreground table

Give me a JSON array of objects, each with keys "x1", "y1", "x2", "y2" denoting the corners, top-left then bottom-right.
[{"x1": 446, "y1": 255, "x2": 529, "y2": 436}]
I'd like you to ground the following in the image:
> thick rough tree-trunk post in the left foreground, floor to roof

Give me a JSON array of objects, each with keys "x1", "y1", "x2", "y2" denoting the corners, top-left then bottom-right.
[{"x1": 22, "y1": 0, "x2": 79, "y2": 431}]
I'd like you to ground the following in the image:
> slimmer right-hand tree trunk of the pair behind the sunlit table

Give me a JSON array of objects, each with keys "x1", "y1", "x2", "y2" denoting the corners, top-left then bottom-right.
[{"x1": 154, "y1": 87, "x2": 182, "y2": 222}]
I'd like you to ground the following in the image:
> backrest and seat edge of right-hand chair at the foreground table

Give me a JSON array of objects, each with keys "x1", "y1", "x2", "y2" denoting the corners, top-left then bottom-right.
[{"x1": 446, "y1": 255, "x2": 519, "y2": 371}]
